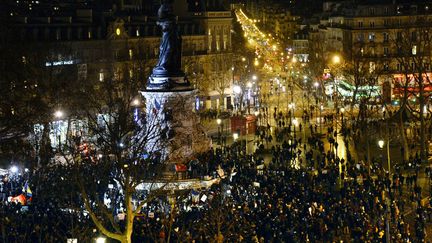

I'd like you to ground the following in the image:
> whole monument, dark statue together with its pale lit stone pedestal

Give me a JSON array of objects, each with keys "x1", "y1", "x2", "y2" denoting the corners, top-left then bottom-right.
[{"x1": 141, "y1": 0, "x2": 211, "y2": 176}]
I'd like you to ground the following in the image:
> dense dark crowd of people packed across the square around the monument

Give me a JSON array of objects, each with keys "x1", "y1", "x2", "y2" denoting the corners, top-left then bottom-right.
[{"x1": 0, "y1": 109, "x2": 432, "y2": 242}]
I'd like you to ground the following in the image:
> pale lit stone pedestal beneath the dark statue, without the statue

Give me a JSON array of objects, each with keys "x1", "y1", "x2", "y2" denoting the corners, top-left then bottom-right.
[{"x1": 141, "y1": 89, "x2": 211, "y2": 170}]
